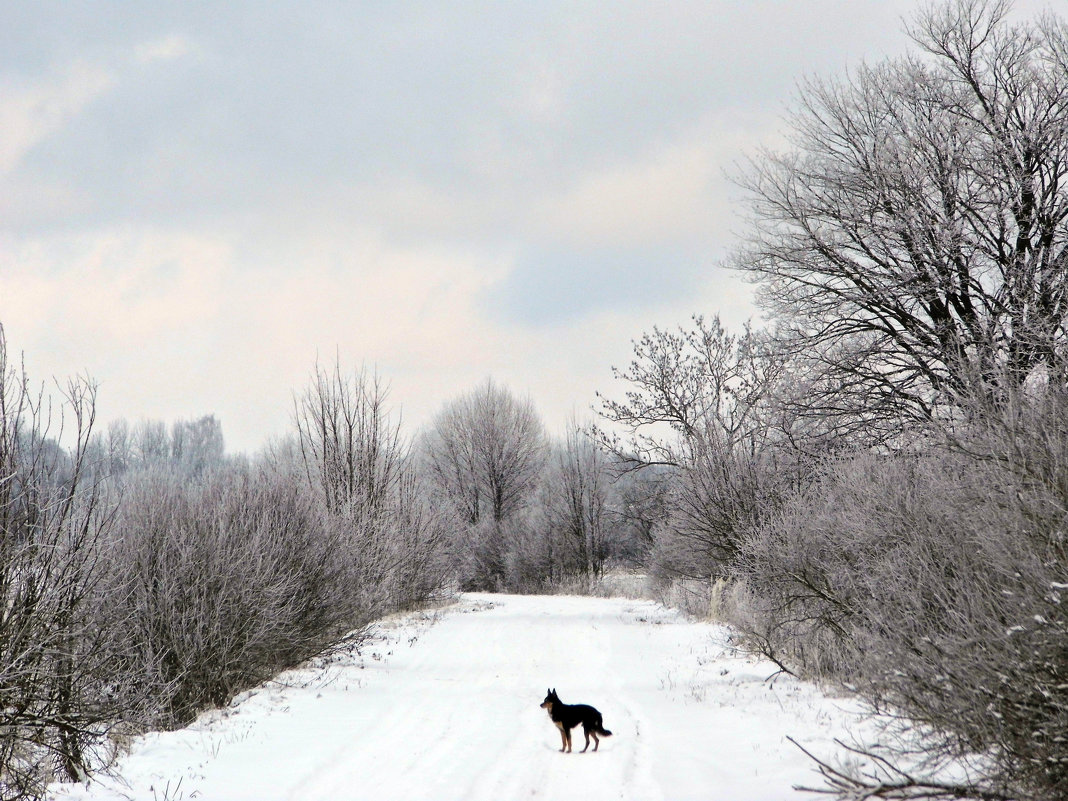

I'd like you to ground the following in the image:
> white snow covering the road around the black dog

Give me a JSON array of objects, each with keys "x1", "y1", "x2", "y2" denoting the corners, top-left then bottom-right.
[{"x1": 49, "y1": 595, "x2": 859, "y2": 801}]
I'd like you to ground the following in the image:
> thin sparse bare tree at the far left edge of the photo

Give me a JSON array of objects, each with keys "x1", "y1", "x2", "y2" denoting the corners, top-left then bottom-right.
[{"x1": 0, "y1": 328, "x2": 113, "y2": 798}]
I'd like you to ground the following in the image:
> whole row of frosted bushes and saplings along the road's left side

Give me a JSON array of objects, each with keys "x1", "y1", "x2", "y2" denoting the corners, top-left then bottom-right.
[{"x1": 0, "y1": 354, "x2": 444, "y2": 798}]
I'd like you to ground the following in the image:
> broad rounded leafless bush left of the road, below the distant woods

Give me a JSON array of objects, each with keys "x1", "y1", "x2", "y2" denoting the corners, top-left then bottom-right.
[{"x1": 108, "y1": 470, "x2": 368, "y2": 724}]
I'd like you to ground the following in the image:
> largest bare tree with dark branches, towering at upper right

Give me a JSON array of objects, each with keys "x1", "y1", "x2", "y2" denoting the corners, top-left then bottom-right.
[{"x1": 736, "y1": 0, "x2": 1068, "y2": 433}]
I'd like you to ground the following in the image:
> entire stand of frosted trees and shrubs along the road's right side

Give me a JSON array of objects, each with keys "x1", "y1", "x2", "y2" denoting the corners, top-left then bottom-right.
[{"x1": 599, "y1": 0, "x2": 1068, "y2": 801}]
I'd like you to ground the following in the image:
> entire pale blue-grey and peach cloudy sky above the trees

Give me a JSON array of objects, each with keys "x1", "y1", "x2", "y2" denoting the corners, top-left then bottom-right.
[{"x1": 0, "y1": 0, "x2": 1042, "y2": 451}]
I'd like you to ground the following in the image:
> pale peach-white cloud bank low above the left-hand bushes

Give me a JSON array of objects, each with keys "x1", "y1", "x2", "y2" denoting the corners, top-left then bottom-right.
[{"x1": 0, "y1": 226, "x2": 511, "y2": 450}]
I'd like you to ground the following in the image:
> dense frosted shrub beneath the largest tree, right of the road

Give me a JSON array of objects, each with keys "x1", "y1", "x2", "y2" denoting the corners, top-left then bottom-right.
[{"x1": 733, "y1": 390, "x2": 1068, "y2": 800}]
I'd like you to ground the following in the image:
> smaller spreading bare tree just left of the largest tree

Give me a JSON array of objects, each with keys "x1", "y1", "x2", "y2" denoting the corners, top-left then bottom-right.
[{"x1": 595, "y1": 316, "x2": 799, "y2": 578}]
